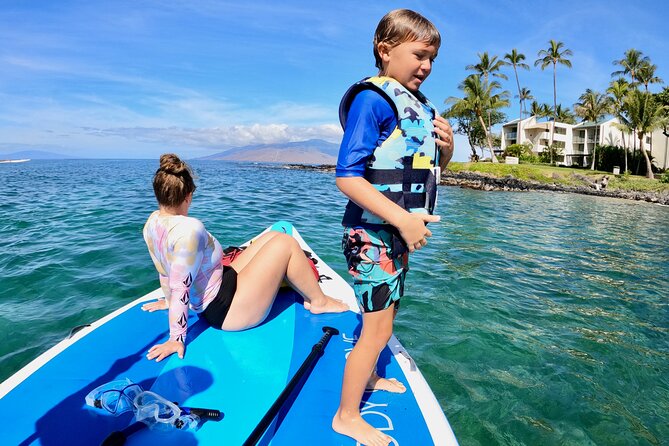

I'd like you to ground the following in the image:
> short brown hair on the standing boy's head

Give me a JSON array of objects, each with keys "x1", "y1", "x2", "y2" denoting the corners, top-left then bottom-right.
[{"x1": 374, "y1": 9, "x2": 441, "y2": 70}]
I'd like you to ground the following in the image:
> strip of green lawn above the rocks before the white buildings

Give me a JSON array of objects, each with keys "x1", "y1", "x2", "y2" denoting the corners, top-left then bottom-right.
[{"x1": 448, "y1": 162, "x2": 669, "y2": 192}]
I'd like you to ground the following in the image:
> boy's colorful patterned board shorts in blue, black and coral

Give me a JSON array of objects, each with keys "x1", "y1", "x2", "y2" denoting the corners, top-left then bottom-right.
[{"x1": 342, "y1": 227, "x2": 409, "y2": 313}]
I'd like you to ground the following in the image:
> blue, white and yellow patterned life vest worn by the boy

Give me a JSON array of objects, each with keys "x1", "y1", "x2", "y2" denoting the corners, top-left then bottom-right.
[{"x1": 339, "y1": 76, "x2": 439, "y2": 226}]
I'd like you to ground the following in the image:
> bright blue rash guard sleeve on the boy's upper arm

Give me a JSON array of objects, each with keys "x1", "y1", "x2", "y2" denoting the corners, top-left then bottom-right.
[{"x1": 336, "y1": 90, "x2": 397, "y2": 177}]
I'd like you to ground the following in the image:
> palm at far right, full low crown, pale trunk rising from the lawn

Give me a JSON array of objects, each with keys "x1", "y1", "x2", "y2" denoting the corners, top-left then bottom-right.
[{"x1": 624, "y1": 90, "x2": 669, "y2": 179}]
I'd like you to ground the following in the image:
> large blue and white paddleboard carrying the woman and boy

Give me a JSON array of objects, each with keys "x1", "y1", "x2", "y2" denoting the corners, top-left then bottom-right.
[{"x1": 0, "y1": 222, "x2": 457, "y2": 446}]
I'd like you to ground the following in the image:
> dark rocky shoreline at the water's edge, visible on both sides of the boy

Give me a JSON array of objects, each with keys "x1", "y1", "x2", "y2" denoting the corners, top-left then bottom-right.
[{"x1": 283, "y1": 164, "x2": 669, "y2": 205}]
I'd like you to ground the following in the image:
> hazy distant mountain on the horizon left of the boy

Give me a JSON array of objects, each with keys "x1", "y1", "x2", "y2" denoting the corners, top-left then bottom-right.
[{"x1": 198, "y1": 139, "x2": 339, "y2": 164}]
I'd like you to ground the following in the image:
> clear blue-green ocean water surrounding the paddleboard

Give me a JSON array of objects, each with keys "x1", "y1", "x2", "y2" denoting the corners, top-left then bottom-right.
[{"x1": 0, "y1": 160, "x2": 669, "y2": 446}]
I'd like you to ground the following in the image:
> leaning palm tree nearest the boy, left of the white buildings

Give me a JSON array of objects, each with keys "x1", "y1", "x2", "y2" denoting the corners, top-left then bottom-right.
[{"x1": 446, "y1": 74, "x2": 509, "y2": 163}]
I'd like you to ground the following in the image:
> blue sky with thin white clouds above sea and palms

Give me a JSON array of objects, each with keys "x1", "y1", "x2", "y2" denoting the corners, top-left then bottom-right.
[{"x1": 0, "y1": 0, "x2": 669, "y2": 161}]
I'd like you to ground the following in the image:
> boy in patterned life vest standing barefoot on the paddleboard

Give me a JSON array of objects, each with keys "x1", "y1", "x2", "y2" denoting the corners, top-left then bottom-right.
[{"x1": 332, "y1": 9, "x2": 453, "y2": 445}]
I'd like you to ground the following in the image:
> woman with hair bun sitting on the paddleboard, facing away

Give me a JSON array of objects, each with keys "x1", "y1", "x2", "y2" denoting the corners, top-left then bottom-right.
[{"x1": 142, "y1": 154, "x2": 348, "y2": 361}]
